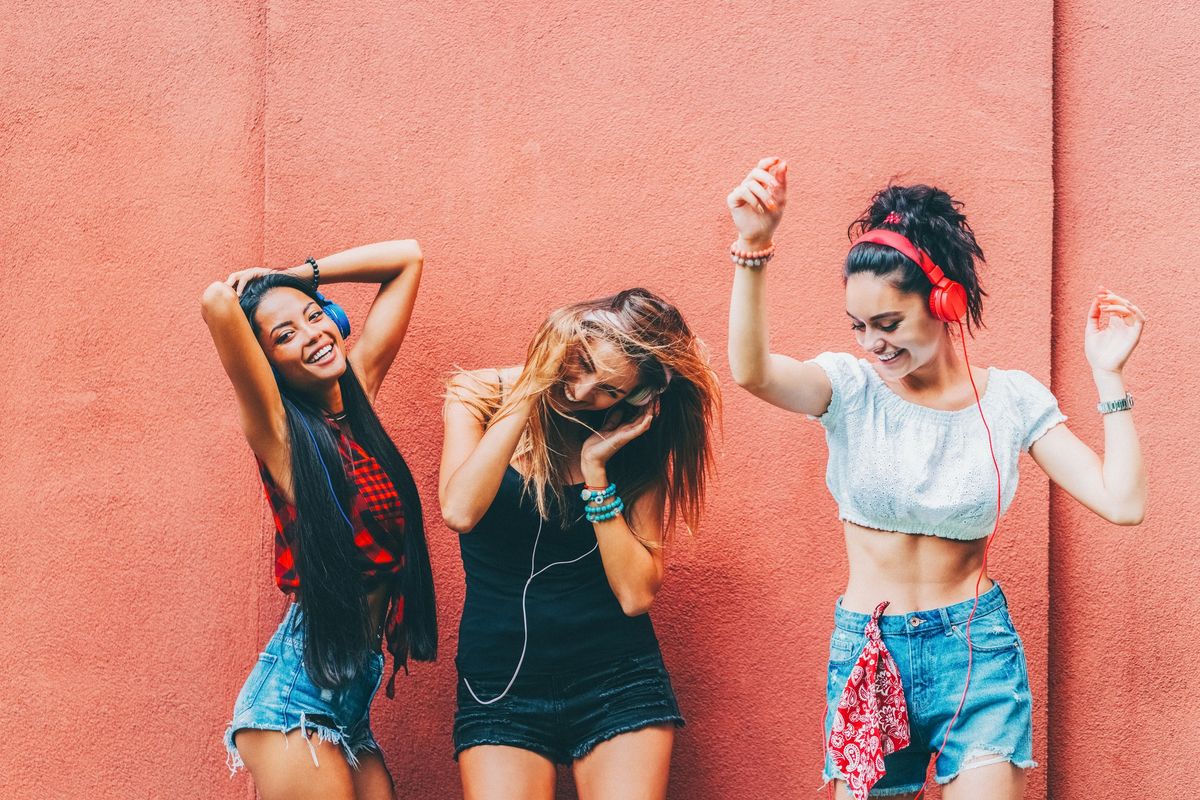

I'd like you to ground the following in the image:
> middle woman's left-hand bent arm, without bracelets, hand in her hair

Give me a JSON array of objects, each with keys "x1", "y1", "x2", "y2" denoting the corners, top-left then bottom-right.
[{"x1": 438, "y1": 369, "x2": 533, "y2": 534}]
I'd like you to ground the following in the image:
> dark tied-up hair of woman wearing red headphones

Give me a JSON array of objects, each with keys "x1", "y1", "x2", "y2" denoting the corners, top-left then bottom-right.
[{"x1": 842, "y1": 185, "x2": 988, "y2": 333}]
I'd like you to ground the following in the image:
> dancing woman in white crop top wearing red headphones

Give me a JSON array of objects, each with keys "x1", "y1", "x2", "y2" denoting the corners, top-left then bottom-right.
[{"x1": 727, "y1": 158, "x2": 1146, "y2": 800}]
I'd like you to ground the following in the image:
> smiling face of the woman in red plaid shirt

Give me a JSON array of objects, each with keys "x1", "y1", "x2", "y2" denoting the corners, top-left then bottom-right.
[{"x1": 254, "y1": 287, "x2": 346, "y2": 390}]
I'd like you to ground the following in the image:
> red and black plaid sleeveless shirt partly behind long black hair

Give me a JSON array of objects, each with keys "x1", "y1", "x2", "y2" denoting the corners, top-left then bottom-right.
[{"x1": 256, "y1": 420, "x2": 408, "y2": 697}]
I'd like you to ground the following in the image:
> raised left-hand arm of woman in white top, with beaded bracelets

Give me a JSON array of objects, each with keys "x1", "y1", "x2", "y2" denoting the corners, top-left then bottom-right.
[{"x1": 726, "y1": 158, "x2": 833, "y2": 416}]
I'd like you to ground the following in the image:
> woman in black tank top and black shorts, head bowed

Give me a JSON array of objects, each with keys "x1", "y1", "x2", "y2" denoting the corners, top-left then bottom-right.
[{"x1": 439, "y1": 289, "x2": 719, "y2": 800}]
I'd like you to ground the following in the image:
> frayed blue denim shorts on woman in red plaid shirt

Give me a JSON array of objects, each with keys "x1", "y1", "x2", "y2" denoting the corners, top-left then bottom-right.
[{"x1": 224, "y1": 603, "x2": 384, "y2": 772}]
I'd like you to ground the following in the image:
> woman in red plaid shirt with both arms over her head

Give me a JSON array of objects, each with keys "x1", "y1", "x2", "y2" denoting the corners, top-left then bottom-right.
[{"x1": 203, "y1": 240, "x2": 437, "y2": 800}]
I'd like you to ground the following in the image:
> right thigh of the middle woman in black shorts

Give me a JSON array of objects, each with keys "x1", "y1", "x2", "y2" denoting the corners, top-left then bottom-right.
[{"x1": 575, "y1": 724, "x2": 674, "y2": 800}]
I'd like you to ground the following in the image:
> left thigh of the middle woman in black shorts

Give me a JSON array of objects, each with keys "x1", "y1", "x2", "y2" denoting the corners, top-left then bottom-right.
[{"x1": 458, "y1": 745, "x2": 558, "y2": 800}]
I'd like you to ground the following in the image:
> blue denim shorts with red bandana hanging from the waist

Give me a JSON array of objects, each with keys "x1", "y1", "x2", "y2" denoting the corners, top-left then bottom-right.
[{"x1": 822, "y1": 584, "x2": 1037, "y2": 798}]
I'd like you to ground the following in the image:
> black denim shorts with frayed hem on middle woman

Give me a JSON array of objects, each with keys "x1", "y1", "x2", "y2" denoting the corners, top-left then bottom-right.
[{"x1": 454, "y1": 652, "x2": 684, "y2": 764}]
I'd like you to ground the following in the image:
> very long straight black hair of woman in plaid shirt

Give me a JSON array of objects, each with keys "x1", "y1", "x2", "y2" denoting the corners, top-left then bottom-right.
[{"x1": 241, "y1": 273, "x2": 438, "y2": 688}]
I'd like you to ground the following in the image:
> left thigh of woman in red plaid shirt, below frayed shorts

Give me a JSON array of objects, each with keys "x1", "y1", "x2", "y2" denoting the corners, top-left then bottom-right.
[{"x1": 234, "y1": 728, "x2": 355, "y2": 800}]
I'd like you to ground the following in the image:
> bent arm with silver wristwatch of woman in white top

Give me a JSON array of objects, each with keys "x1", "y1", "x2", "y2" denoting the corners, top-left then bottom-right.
[{"x1": 1030, "y1": 289, "x2": 1146, "y2": 525}]
